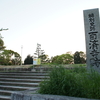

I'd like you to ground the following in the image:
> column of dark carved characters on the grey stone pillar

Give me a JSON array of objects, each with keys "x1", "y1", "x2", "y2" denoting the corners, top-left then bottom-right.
[{"x1": 88, "y1": 13, "x2": 100, "y2": 67}]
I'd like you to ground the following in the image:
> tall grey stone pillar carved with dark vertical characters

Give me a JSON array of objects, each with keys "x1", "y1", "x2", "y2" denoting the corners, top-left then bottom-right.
[{"x1": 83, "y1": 8, "x2": 100, "y2": 72}]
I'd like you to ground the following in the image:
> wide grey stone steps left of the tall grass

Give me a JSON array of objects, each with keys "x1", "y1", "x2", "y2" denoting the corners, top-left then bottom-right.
[{"x1": 0, "y1": 70, "x2": 48, "y2": 100}]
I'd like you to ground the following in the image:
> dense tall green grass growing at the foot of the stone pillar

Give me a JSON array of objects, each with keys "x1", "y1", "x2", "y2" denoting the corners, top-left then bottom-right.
[{"x1": 39, "y1": 66, "x2": 100, "y2": 99}]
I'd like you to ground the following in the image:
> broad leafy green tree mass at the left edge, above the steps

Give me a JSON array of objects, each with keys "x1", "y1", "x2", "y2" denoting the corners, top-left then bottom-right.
[{"x1": 0, "y1": 37, "x2": 21, "y2": 65}]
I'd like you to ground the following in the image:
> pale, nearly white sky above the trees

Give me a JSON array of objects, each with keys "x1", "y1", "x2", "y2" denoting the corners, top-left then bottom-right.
[{"x1": 0, "y1": 0, "x2": 100, "y2": 60}]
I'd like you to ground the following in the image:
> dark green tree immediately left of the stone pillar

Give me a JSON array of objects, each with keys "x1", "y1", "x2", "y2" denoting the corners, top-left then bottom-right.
[{"x1": 74, "y1": 51, "x2": 86, "y2": 64}]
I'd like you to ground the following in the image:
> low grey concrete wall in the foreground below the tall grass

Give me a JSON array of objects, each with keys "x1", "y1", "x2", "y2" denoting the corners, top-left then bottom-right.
[{"x1": 11, "y1": 92, "x2": 97, "y2": 100}]
